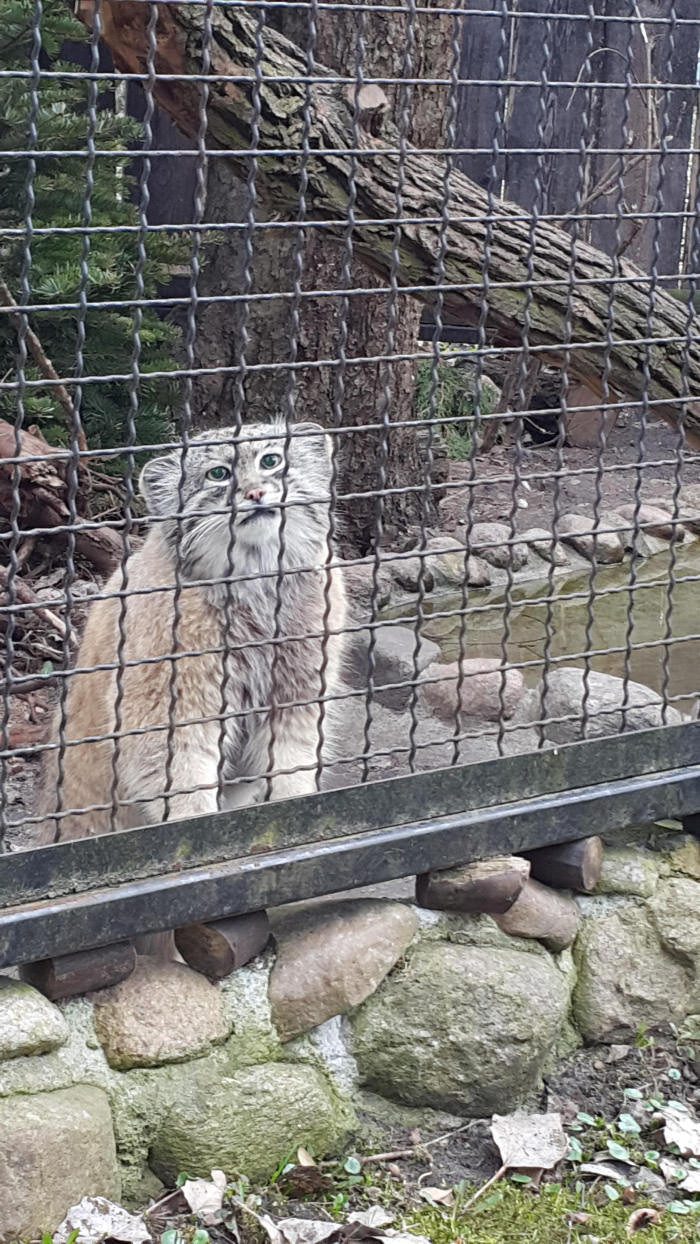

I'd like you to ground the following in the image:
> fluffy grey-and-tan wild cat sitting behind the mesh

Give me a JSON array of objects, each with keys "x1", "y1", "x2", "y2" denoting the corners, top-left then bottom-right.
[{"x1": 36, "y1": 423, "x2": 346, "y2": 841}]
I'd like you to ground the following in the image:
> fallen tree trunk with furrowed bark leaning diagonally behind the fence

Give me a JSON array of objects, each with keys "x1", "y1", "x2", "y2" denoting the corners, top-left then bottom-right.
[{"x1": 86, "y1": 0, "x2": 700, "y2": 445}]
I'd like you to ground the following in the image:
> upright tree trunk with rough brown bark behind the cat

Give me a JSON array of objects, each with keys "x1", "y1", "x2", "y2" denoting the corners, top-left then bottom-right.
[{"x1": 194, "y1": 0, "x2": 453, "y2": 554}]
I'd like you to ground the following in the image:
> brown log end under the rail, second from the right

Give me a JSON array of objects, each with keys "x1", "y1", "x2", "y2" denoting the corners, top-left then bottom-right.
[{"x1": 415, "y1": 856, "x2": 530, "y2": 914}]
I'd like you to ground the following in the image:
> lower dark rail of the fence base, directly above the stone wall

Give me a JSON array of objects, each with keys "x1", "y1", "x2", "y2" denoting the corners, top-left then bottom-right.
[{"x1": 0, "y1": 758, "x2": 700, "y2": 967}]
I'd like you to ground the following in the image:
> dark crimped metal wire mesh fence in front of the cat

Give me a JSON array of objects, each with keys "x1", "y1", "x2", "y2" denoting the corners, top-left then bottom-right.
[{"x1": 0, "y1": 0, "x2": 700, "y2": 888}]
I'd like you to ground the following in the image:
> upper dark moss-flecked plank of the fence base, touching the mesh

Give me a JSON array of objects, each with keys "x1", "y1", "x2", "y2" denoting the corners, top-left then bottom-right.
[{"x1": 0, "y1": 722, "x2": 700, "y2": 905}]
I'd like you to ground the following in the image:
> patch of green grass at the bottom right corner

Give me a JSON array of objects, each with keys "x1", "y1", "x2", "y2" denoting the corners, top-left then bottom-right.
[{"x1": 405, "y1": 1183, "x2": 700, "y2": 1244}]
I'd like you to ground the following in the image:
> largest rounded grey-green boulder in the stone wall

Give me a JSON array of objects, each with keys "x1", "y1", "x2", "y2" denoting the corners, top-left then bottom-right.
[{"x1": 353, "y1": 942, "x2": 568, "y2": 1116}]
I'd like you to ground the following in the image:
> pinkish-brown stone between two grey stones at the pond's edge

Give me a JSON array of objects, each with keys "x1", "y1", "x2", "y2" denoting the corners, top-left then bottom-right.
[{"x1": 420, "y1": 657, "x2": 525, "y2": 722}]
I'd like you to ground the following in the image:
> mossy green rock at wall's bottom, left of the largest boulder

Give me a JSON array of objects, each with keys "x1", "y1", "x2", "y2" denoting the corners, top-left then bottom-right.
[{"x1": 149, "y1": 1060, "x2": 354, "y2": 1186}]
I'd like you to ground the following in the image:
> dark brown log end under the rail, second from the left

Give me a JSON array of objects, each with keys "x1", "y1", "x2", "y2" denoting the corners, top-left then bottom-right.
[{"x1": 175, "y1": 912, "x2": 270, "y2": 980}]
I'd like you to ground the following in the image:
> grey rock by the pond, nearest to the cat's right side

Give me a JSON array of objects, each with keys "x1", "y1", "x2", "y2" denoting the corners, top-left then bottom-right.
[{"x1": 346, "y1": 624, "x2": 440, "y2": 710}]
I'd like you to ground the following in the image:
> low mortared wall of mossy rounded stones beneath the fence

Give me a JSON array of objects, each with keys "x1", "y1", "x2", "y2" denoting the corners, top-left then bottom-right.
[{"x1": 0, "y1": 826, "x2": 700, "y2": 1239}]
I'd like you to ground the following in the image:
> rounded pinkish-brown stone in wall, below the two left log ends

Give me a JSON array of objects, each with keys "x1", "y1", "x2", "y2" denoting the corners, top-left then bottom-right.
[{"x1": 94, "y1": 955, "x2": 231, "y2": 1070}]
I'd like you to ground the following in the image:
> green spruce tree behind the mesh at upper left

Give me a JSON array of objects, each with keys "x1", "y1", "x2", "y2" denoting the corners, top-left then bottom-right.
[{"x1": 0, "y1": 0, "x2": 182, "y2": 449}]
